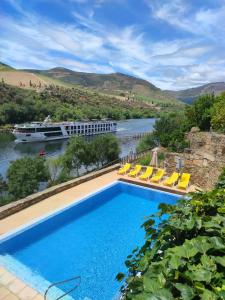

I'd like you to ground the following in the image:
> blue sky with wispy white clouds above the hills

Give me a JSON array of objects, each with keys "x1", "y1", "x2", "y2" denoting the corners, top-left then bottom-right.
[{"x1": 0, "y1": 0, "x2": 225, "y2": 90}]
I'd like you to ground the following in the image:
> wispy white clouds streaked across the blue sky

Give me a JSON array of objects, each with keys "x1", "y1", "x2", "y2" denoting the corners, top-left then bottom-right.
[{"x1": 0, "y1": 0, "x2": 225, "y2": 89}]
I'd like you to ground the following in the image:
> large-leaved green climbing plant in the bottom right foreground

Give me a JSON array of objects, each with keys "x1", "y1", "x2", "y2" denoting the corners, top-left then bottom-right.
[{"x1": 117, "y1": 189, "x2": 225, "y2": 300}]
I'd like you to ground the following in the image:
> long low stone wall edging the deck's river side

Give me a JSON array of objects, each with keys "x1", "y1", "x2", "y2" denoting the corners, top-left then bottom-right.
[{"x1": 0, "y1": 164, "x2": 120, "y2": 220}]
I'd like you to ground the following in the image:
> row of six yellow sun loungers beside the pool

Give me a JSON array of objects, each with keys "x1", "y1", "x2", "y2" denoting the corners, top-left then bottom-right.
[{"x1": 118, "y1": 163, "x2": 191, "y2": 190}]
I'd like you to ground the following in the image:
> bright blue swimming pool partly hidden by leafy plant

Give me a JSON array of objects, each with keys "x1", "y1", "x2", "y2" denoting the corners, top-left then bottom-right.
[{"x1": 0, "y1": 182, "x2": 180, "y2": 300}]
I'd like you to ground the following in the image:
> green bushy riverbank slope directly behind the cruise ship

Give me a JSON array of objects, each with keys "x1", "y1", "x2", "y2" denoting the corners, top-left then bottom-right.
[{"x1": 0, "y1": 82, "x2": 157, "y2": 125}]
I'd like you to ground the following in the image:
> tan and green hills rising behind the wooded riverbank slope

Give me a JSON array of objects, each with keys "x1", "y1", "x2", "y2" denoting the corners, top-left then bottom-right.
[{"x1": 0, "y1": 64, "x2": 182, "y2": 109}]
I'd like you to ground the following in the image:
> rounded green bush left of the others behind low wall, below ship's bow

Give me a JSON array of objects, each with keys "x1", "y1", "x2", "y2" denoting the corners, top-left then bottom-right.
[{"x1": 7, "y1": 157, "x2": 49, "y2": 199}]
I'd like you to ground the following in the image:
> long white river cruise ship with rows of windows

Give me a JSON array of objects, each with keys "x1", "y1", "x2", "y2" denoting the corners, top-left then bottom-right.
[{"x1": 13, "y1": 116, "x2": 117, "y2": 143}]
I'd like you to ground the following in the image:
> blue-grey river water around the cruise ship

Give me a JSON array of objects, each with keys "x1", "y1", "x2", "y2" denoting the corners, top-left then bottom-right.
[{"x1": 0, "y1": 119, "x2": 155, "y2": 177}]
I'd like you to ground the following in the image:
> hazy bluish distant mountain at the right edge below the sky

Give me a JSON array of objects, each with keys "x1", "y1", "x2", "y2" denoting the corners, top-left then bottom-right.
[{"x1": 166, "y1": 82, "x2": 225, "y2": 104}]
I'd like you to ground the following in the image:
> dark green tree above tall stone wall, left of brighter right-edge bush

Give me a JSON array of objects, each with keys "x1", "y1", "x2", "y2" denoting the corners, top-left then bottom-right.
[{"x1": 186, "y1": 94, "x2": 215, "y2": 131}]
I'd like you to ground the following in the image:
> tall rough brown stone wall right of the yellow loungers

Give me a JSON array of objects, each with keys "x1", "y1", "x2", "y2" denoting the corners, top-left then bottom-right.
[{"x1": 163, "y1": 130, "x2": 225, "y2": 190}]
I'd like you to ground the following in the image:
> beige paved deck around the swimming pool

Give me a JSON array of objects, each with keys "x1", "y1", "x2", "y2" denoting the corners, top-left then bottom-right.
[{"x1": 0, "y1": 171, "x2": 194, "y2": 300}]
